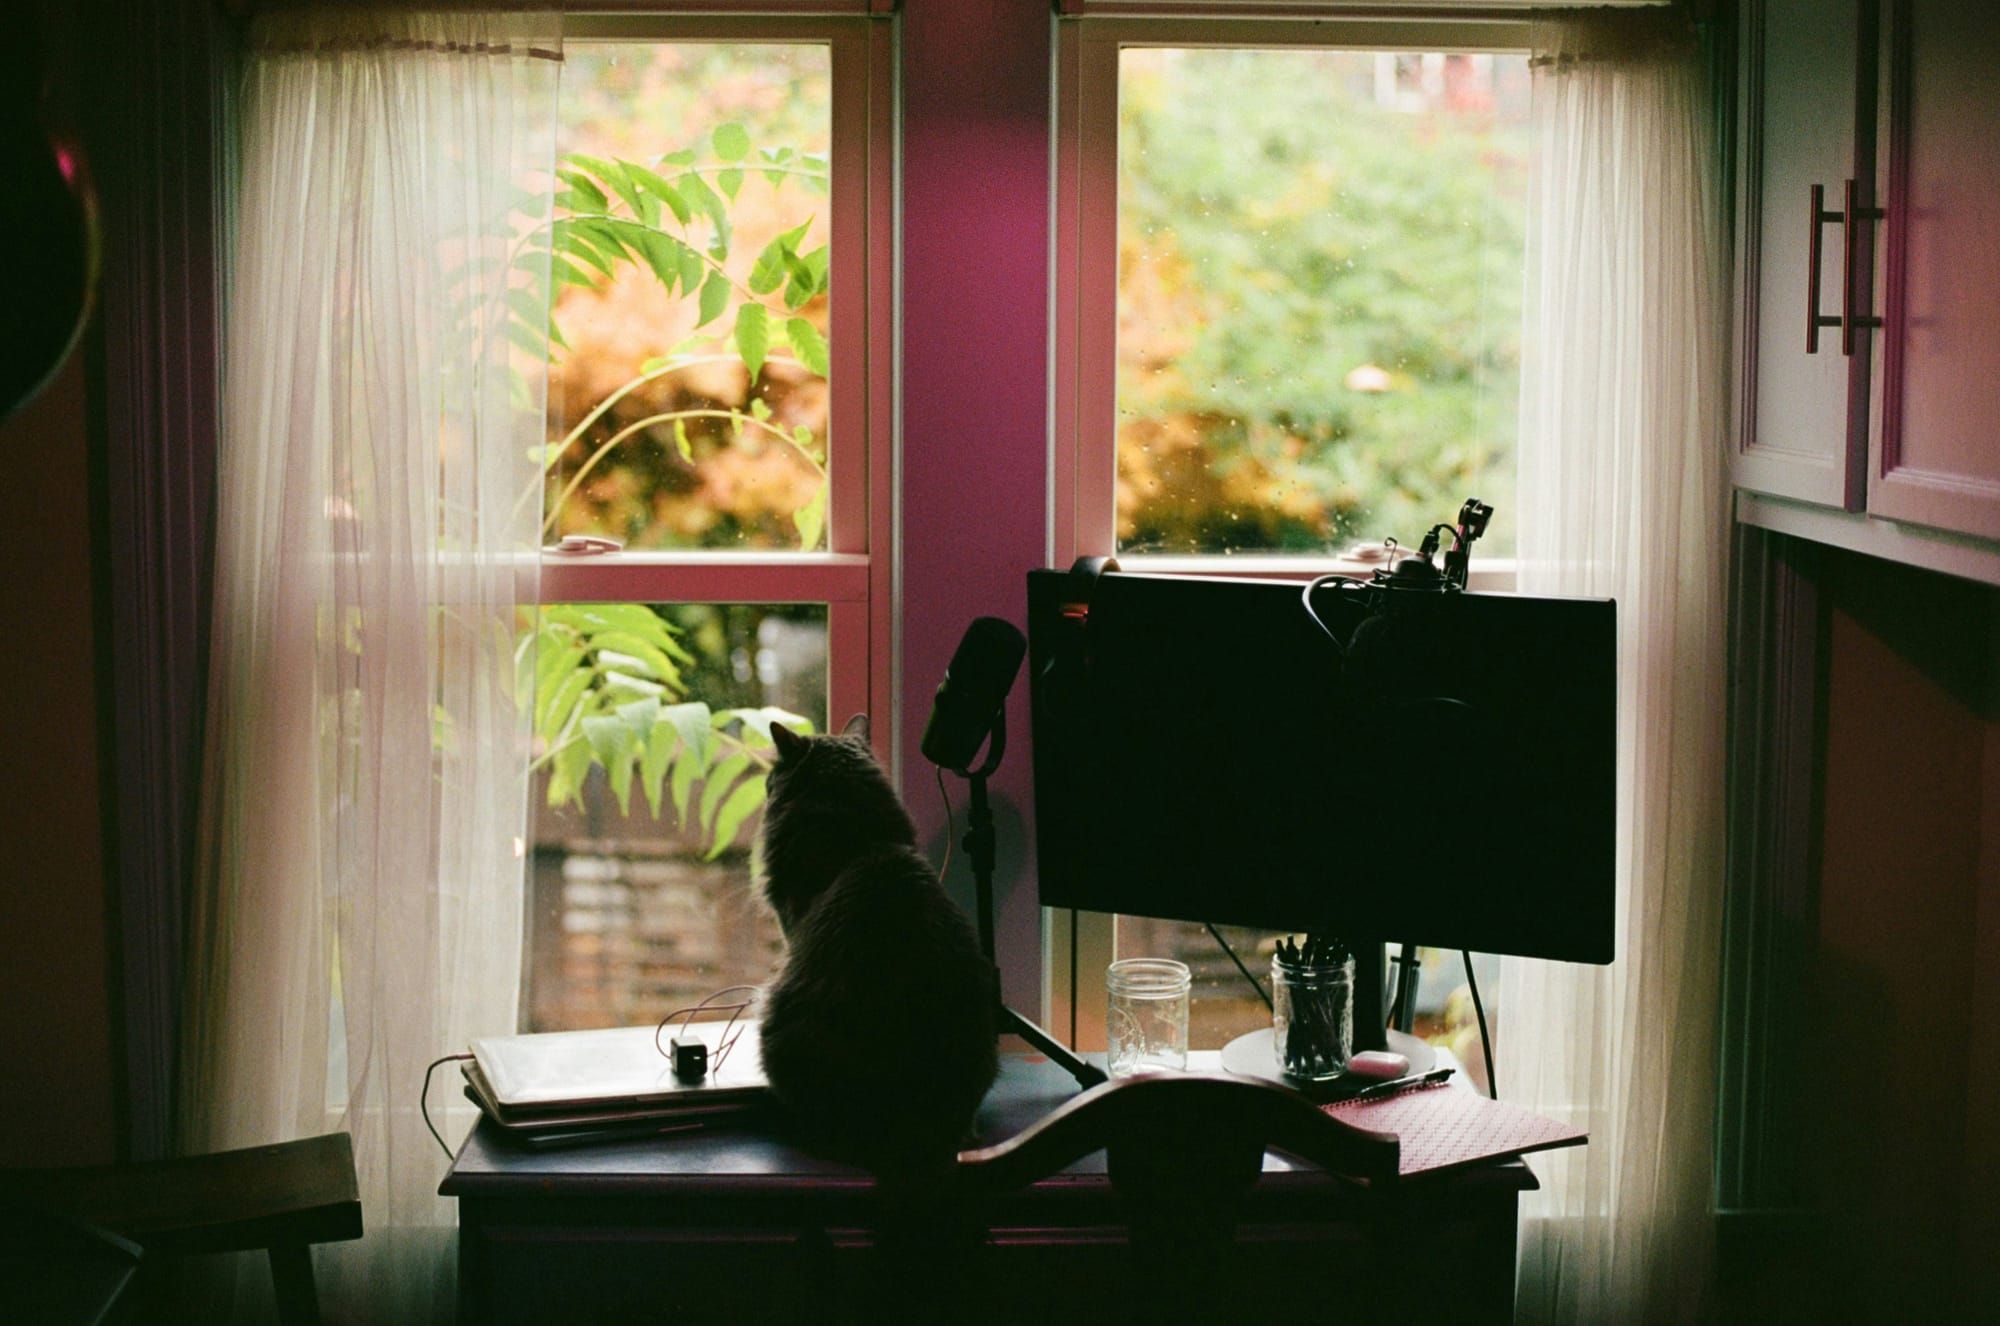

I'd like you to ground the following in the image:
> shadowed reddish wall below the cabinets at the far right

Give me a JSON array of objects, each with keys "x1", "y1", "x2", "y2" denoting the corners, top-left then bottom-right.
[{"x1": 1806, "y1": 558, "x2": 2000, "y2": 1320}]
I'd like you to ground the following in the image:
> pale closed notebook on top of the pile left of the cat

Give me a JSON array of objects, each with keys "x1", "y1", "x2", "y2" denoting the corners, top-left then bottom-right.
[{"x1": 466, "y1": 1020, "x2": 770, "y2": 1122}]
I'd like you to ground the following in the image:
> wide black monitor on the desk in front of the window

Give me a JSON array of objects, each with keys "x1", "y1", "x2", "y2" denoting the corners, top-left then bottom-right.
[{"x1": 1028, "y1": 570, "x2": 1618, "y2": 962}]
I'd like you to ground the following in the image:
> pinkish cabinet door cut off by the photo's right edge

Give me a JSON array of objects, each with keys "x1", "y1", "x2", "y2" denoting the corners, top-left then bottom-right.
[{"x1": 1868, "y1": 0, "x2": 2000, "y2": 538}]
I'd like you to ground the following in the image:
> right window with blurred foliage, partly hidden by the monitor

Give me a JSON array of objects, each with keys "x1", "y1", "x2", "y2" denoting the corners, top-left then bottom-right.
[{"x1": 1048, "y1": 18, "x2": 1528, "y2": 1080}]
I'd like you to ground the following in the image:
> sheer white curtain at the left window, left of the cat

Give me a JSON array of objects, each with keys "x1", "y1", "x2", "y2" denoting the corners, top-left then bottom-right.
[{"x1": 182, "y1": 12, "x2": 562, "y2": 1322}]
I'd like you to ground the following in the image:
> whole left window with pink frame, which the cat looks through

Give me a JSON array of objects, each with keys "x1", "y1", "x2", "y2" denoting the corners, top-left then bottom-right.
[{"x1": 522, "y1": 18, "x2": 890, "y2": 1030}]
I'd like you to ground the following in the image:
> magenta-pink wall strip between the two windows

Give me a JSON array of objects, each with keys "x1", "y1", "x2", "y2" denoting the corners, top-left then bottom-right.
[{"x1": 898, "y1": 0, "x2": 1050, "y2": 1000}]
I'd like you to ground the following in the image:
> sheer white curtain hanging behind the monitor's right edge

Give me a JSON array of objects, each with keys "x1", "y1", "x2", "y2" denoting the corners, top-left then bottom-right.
[{"x1": 1498, "y1": 16, "x2": 1728, "y2": 1322}]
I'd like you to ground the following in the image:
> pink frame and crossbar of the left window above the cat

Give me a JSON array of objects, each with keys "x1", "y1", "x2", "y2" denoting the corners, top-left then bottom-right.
[{"x1": 538, "y1": 14, "x2": 896, "y2": 768}]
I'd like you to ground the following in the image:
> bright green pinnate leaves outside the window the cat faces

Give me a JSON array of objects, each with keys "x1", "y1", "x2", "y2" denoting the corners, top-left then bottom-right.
[{"x1": 510, "y1": 96, "x2": 828, "y2": 858}]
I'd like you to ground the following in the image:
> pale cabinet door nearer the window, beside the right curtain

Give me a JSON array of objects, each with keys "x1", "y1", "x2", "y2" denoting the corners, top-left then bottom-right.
[{"x1": 1732, "y1": 0, "x2": 1876, "y2": 510}]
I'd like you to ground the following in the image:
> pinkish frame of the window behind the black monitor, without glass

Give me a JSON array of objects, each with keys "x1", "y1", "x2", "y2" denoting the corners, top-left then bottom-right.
[{"x1": 1042, "y1": 14, "x2": 1530, "y2": 1048}]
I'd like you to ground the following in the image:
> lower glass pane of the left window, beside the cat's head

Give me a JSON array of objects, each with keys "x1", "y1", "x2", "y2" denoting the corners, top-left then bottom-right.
[{"x1": 524, "y1": 604, "x2": 826, "y2": 1032}]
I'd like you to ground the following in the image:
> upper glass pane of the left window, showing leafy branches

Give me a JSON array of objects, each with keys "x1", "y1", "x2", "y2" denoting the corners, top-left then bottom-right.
[{"x1": 546, "y1": 42, "x2": 832, "y2": 550}]
